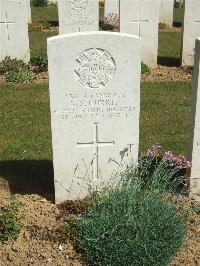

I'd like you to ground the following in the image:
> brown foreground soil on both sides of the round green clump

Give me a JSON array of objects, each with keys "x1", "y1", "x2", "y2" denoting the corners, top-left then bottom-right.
[{"x1": 0, "y1": 176, "x2": 200, "y2": 266}]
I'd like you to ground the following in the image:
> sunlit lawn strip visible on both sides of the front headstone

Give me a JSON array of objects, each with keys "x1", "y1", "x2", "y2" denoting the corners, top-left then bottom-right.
[{"x1": 0, "y1": 82, "x2": 191, "y2": 160}]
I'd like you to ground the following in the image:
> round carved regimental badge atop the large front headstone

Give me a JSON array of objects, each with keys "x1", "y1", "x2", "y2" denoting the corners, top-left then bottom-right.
[{"x1": 74, "y1": 48, "x2": 116, "y2": 89}]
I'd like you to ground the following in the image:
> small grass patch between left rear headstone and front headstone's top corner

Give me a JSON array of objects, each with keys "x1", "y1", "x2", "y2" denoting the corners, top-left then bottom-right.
[{"x1": 29, "y1": 31, "x2": 58, "y2": 57}]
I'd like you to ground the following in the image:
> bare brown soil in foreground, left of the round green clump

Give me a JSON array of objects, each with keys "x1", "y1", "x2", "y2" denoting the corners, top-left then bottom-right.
[{"x1": 0, "y1": 181, "x2": 85, "y2": 266}]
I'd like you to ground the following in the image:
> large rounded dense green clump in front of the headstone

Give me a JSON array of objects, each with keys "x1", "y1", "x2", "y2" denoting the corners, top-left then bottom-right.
[{"x1": 75, "y1": 187, "x2": 186, "y2": 266}]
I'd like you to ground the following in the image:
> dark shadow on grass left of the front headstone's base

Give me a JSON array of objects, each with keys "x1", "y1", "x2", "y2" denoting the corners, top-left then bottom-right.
[{"x1": 0, "y1": 160, "x2": 54, "y2": 202}]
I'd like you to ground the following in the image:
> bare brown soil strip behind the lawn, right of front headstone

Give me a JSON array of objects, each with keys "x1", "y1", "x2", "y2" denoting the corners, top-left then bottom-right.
[{"x1": 142, "y1": 65, "x2": 192, "y2": 82}]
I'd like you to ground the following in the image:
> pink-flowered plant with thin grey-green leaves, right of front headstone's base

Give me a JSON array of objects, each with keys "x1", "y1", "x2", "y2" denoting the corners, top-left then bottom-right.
[{"x1": 138, "y1": 145, "x2": 192, "y2": 192}]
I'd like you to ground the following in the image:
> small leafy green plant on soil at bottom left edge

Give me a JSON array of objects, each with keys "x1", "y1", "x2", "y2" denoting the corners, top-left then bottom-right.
[{"x1": 0, "y1": 196, "x2": 24, "y2": 242}]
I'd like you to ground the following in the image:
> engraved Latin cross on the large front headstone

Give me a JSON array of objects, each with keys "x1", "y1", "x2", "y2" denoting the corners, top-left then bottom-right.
[{"x1": 77, "y1": 123, "x2": 115, "y2": 181}]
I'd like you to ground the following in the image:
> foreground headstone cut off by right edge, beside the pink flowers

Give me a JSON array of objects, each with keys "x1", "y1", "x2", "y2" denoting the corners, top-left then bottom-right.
[{"x1": 189, "y1": 38, "x2": 200, "y2": 200}]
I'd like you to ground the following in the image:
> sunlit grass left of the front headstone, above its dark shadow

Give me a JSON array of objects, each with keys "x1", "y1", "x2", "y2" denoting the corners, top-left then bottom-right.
[{"x1": 0, "y1": 84, "x2": 52, "y2": 160}]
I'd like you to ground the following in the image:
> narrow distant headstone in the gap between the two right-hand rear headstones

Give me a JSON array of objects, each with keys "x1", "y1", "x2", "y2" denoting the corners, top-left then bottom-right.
[{"x1": 160, "y1": 0, "x2": 174, "y2": 27}]
